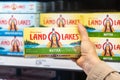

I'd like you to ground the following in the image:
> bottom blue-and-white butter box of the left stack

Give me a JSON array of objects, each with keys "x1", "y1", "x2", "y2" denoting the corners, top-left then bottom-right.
[{"x1": 0, "y1": 36, "x2": 24, "y2": 56}]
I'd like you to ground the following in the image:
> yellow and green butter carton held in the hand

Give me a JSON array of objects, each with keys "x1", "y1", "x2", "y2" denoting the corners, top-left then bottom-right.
[{"x1": 24, "y1": 27, "x2": 81, "y2": 58}]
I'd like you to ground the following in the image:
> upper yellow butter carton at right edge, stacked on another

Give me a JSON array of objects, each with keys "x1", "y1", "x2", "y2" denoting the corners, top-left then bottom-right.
[{"x1": 83, "y1": 13, "x2": 120, "y2": 37}]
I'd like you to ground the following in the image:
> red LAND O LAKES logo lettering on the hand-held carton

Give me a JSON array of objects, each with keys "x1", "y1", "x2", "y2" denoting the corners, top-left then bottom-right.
[{"x1": 29, "y1": 28, "x2": 80, "y2": 41}]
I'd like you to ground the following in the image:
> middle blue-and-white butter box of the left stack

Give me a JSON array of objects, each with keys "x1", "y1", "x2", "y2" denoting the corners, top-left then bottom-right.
[{"x1": 0, "y1": 14, "x2": 39, "y2": 36}]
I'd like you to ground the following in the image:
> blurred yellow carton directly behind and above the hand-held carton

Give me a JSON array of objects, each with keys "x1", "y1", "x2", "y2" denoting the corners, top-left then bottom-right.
[{"x1": 40, "y1": 13, "x2": 83, "y2": 28}]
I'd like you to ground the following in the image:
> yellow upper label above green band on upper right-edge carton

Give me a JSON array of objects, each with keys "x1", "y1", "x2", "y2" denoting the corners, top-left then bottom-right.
[{"x1": 84, "y1": 13, "x2": 120, "y2": 32}]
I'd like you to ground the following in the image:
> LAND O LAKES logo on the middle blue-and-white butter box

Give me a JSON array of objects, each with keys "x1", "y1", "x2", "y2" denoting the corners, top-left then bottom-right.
[{"x1": 0, "y1": 14, "x2": 33, "y2": 31}]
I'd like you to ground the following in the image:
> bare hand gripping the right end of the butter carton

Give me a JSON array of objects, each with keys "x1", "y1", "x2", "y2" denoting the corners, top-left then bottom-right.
[{"x1": 76, "y1": 24, "x2": 101, "y2": 74}]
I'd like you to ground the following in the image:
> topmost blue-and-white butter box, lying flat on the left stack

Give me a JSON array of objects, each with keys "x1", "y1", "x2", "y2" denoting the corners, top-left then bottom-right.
[{"x1": 0, "y1": 1, "x2": 43, "y2": 13}]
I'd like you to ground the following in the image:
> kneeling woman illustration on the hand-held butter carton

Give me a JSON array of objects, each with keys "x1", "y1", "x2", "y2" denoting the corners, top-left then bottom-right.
[{"x1": 47, "y1": 28, "x2": 62, "y2": 48}]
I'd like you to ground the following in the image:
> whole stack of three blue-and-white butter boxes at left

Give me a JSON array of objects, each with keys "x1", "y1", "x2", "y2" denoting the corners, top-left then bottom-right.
[{"x1": 0, "y1": 1, "x2": 42, "y2": 56}]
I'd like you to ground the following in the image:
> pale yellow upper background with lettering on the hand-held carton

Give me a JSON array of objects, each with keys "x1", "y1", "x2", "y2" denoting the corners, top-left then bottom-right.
[{"x1": 24, "y1": 28, "x2": 80, "y2": 45}]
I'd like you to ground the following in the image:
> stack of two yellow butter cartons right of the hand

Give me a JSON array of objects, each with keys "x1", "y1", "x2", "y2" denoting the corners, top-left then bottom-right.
[{"x1": 84, "y1": 13, "x2": 120, "y2": 61}]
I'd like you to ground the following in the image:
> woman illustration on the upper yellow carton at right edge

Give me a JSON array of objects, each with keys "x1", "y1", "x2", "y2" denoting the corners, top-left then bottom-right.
[{"x1": 102, "y1": 15, "x2": 114, "y2": 32}]
